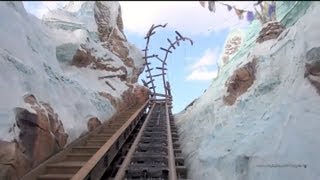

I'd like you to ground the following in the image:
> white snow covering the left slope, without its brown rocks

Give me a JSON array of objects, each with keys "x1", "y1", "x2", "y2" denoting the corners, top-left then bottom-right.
[{"x1": 0, "y1": 2, "x2": 138, "y2": 143}]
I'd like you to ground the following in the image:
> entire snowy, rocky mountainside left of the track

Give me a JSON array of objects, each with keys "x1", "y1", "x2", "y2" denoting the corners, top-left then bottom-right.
[{"x1": 0, "y1": 1, "x2": 148, "y2": 179}]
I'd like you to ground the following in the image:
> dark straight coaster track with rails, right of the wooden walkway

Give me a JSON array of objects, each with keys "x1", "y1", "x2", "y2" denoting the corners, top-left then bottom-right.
[{"x1": 114, "y1": 101, "x2": 182, "y2": 180}]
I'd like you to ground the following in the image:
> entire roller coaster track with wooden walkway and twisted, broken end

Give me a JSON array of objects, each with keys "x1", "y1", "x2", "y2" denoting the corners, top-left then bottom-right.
[{"x1": 21, "y1": 25, "x2": 193, "y2": 180}]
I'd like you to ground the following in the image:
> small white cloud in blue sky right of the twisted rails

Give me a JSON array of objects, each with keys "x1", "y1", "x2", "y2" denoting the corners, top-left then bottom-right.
[{"x1": 186, "y1": 49, "x2": 218, "y2": 81}]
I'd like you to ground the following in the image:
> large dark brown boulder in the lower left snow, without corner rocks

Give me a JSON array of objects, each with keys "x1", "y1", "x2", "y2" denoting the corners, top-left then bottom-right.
[{"x1": 16, "y1": 94, "x2": 68, "y2": 163}]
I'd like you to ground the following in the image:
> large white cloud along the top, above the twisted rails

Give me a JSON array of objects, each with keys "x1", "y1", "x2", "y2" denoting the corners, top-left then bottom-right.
[{"x1": 120, "y1": 1, "x2": 255, "y2": 36}]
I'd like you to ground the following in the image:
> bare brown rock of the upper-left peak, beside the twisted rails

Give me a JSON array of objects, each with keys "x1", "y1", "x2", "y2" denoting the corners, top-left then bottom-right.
[{"x1": 72, "y1": 1, "x2": 143, "y2": 83}]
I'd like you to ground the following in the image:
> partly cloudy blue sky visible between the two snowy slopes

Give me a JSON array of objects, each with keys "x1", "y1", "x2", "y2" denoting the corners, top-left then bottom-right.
[{"x1": 24, "y1": 1, "x2": 254, "y2": 113}]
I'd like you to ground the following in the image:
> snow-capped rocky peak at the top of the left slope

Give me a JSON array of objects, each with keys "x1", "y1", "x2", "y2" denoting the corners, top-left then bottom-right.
[{"x1": 43, "y1": 1, "x2": 144, "y2": 83}]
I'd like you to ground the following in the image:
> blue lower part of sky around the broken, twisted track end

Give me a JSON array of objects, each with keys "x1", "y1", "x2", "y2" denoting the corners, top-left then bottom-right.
[{"x1": 125, "y1": 29, "x2": 228, "y2": 113}]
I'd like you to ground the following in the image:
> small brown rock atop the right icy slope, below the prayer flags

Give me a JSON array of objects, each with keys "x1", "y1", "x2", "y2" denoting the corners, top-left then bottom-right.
[{"x1": 256, "y1": 21, "x2": 285, "y2": 43}]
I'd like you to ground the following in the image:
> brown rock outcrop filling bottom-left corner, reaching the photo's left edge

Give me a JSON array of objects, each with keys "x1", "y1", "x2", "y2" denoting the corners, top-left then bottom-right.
[{"x1": 0, "y1": 94, "x2": 68, "y2": 179}]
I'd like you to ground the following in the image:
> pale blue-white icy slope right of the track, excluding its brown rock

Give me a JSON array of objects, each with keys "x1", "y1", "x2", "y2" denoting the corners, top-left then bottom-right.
[{"x1": 175, "y1": 1, "x2": 320, "y2": 180}]
